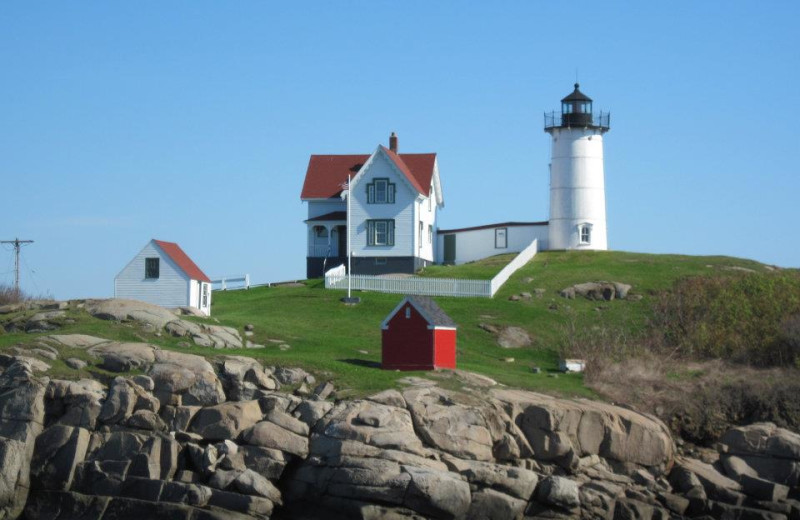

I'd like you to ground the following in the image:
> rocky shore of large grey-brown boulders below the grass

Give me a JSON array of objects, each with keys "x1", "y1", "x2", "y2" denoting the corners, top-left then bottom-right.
[{"x1": 0, "y1": 298, "x2": 800, "y2": 520}]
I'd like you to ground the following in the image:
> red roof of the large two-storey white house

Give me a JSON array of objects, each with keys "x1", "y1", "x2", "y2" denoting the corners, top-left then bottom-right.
[{"x1": 300, "y1": 150, "x2": 436, "y2": 199}]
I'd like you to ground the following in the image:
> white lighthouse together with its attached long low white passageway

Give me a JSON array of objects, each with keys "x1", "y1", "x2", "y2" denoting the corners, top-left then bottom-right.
[{"x1": 436, "y1": 83, "x2": 611, "y2": 264}]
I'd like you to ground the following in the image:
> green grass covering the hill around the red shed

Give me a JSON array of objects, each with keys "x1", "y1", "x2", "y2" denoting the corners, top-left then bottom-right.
[{"x1": 0, "y1": 252, "x2": 776, "y2": 397}]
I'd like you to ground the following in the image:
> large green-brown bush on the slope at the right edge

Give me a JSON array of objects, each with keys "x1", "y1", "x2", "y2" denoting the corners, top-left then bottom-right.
[{"x1": 650, "y1": 271, "x2": 800, "y2": 366}]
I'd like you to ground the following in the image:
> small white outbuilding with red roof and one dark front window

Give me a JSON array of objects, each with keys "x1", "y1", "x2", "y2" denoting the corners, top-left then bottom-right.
[{"x1": 114, "y1": 239, "x2": 211, "y2": 316}]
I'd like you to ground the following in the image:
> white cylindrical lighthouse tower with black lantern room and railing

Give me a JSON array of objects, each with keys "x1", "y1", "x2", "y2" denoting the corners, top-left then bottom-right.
[{"x1": 544, "y1": 83, "x2": 611, "y2": 250}]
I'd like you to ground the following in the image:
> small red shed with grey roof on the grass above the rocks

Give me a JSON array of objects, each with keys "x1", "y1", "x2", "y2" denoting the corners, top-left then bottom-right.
[{"x1": 381, "y1": 296, "x2": 456, "y2": 370}]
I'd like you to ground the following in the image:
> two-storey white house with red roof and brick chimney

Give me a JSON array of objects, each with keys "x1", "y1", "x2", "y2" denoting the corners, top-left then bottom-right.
[{"x1": 300, "y1": 133, "x2": 444, "y2": 278}]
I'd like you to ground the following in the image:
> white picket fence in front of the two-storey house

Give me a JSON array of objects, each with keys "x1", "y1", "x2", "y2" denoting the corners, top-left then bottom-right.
[{"x1": 325, "y1": 240, "x2": 538, "y2": 298}]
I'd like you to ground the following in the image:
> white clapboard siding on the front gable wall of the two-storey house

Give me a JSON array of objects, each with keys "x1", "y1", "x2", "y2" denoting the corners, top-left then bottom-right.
[{"x1": 350, "y1": 151, "x2": 418, "y2": 256}]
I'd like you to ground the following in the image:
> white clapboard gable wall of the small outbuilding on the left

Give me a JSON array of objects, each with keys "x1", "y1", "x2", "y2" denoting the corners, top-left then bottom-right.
[{"x1": 114, "y1": 241, "x2": 191, "y2": 307}]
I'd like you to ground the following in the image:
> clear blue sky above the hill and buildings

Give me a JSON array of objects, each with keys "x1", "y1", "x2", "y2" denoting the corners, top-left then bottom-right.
[{"x1": 0, "y1": 1, "x2": 800, "y2": 298}]
